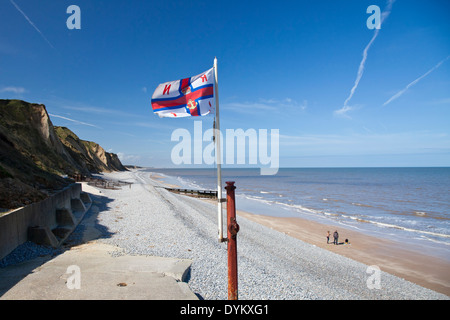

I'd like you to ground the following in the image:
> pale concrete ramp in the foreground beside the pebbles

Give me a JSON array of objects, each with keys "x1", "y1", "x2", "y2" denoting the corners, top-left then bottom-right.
[{"x1": 0, "y1": 242, "x2": 198, "y2": 300}]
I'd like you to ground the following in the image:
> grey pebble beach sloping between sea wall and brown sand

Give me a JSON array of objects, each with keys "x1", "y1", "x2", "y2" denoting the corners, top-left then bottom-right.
[{"x1": 2, "y1": 170, "x2": 449, "y2": 300}]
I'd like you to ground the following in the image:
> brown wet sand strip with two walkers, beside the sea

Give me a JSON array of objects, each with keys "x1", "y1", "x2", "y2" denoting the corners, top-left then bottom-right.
[{"x1": 237, "y1": 210, "x2": 450, "y2": 296}]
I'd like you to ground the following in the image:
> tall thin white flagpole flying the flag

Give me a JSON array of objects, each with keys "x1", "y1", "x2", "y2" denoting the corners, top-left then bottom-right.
[{"x1": 214, "y1": 57, "x2": 223, "y2": 242}]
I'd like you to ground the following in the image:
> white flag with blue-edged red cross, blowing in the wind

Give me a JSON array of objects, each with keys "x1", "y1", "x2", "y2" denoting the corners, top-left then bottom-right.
[{"x1": 152, "y1": 68, "x2": 215, "y2": 118}]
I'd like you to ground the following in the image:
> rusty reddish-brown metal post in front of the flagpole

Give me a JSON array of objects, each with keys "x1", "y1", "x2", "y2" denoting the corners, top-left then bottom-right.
[{"x1": 225, "y1": 181, "x2": 239, "y2": 300}]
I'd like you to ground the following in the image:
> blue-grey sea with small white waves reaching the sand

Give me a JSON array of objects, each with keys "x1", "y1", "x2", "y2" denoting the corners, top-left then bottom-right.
[{"x1": 146, "y1": 167, "x2": 450, "y2": 261}]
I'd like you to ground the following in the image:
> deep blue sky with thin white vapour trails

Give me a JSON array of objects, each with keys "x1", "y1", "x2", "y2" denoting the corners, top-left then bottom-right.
[{"x1": 0, "y1": 0, "x2": 450, "y2": 167}]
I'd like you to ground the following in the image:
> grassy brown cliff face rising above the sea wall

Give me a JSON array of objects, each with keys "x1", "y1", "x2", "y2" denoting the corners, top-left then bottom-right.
[{"x1": 0, "y1": 99, "x2": 126, "y2": 209}]
